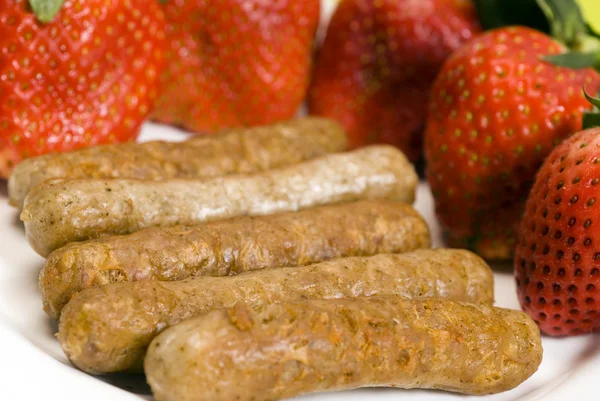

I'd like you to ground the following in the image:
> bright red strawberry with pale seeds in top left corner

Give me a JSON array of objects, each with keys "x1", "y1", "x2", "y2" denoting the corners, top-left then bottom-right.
[{"x1": 0, "y1": 0, "x2": 166, "y2": 178}]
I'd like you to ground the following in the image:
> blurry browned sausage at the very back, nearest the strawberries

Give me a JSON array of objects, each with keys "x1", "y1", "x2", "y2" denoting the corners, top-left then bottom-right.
[{"x1": 8, "y1": 118, "x2": 346, "y2": 208}]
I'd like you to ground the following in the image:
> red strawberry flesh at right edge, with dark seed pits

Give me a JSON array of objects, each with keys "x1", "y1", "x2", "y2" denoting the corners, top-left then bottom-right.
[{"x1": 515, "y1": 128, "x2": 600, "y2": 336}]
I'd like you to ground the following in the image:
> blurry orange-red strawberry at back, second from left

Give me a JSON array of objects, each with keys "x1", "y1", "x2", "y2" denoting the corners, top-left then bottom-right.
[{"x1": 152, "y1": 0, "x2": 320, "y2": 133}]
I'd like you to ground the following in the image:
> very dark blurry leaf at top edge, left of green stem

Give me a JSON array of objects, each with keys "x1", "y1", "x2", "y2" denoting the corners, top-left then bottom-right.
[{"x1": 474, "y1": 0, "x2": 550, "y2": 33}]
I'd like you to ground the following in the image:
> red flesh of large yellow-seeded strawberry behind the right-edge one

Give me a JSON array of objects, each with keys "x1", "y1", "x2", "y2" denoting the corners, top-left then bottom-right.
[{"x1": 425, "y1": 27, "x2": 600, "y2": 259}]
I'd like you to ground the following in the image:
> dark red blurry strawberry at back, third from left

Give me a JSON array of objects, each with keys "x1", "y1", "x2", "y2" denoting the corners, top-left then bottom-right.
[{"x1": 308, "y1": 0, "x2": 480, "y2": 160}]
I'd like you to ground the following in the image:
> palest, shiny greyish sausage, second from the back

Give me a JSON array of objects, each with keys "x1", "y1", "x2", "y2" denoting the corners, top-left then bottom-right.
[{"x1": 21, "y1": 146, "x2": 418, "y2": 256}]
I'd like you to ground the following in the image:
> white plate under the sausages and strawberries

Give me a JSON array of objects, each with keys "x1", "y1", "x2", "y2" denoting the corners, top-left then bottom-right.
[{"x1": 0, "y1": 124, "x2": 600, "y2": 401}]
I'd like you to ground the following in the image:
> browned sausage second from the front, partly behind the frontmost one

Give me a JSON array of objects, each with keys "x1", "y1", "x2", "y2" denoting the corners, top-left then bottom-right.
[{"x1": 58, "y1": 250, "x2": 493, "y2": 373}]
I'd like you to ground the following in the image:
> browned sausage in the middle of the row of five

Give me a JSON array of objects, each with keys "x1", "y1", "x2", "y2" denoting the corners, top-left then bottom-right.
[{"x1": 40, "y1": 201, "x2": 429, "y2": 318}]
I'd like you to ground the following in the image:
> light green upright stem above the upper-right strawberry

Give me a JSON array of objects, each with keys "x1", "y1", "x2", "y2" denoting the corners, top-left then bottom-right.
[{"x1": 537, "y1": 0, "x2": 588, "y2": 49}]
